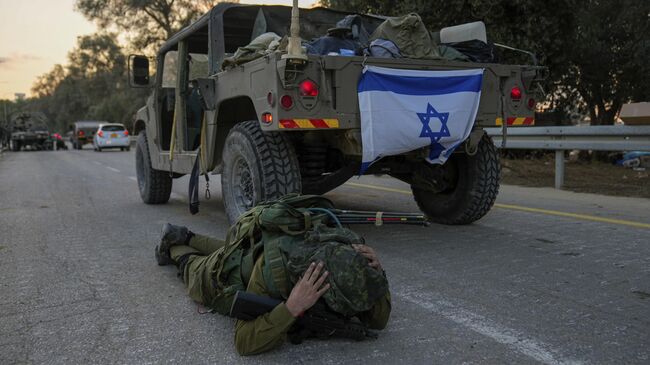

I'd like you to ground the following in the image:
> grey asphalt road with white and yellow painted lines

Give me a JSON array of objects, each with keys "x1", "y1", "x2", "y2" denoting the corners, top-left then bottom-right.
[{"x1": 0, "y1": 146, "x2": 650, "y2": 364}]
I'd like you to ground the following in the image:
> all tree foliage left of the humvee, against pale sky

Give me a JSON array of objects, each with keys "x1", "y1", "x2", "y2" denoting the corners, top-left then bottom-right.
[{"x1": 0, "y1": 0, "x2": 236, "y2": 132}]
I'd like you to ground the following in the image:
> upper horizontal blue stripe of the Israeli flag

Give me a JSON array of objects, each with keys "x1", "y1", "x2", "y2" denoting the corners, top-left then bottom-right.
[{"x1": 358, "y1": 71, "x2": 483, "y2": 95}]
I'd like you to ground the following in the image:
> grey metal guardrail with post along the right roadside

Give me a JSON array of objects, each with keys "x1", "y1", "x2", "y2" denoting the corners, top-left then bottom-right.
[{"x1": 485, "y1": 125, "x2": 650, "y2": 189}]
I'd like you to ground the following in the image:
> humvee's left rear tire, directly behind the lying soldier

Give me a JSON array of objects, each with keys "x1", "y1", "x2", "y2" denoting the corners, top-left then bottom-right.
[{"x1": 221, "y1": 120, "x2": 301, "y2": 223}]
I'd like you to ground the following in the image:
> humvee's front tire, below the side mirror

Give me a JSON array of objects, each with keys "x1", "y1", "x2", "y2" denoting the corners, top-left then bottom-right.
[{"x1": 135, "y1": 131, "x2": 172, "y2": 204}]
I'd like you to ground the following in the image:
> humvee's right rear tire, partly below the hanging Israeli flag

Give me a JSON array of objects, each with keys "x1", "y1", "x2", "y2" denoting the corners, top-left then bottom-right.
[{"x1": 411, "y1": 135, "x2": 501, "y2": 224}]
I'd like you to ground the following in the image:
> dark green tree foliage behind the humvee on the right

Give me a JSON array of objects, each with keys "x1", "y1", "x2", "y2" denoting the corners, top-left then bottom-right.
[{"x1": 321, "y1": 0, "x2": 650, "y2": 124}]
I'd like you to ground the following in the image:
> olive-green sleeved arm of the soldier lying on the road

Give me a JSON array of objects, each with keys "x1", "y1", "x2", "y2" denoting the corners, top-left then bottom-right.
[{"x1": 235, "y1": 258, "x2": 295, "y2": 355}]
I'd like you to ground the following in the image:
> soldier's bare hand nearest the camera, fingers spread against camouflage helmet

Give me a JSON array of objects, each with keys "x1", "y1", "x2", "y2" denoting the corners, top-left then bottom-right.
[{"x1": 286, "y1": 262, "x2": 330, "y2": 317}]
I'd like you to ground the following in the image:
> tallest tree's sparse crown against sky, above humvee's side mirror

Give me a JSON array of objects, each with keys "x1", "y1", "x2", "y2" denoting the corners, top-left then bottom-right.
[{"x1": 75, "y1": 0, "x2": 229, "y2": 51}]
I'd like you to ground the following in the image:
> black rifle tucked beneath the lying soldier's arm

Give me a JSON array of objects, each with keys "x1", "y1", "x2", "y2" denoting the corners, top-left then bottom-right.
[{"x1": 230, "y1": 290, "x2": 377, "y2": 344}]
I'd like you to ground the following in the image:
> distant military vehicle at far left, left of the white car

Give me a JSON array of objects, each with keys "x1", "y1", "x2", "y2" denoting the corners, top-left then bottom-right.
[{"x1": 8, "y1": 112, "x2": 50, "y2": 151}]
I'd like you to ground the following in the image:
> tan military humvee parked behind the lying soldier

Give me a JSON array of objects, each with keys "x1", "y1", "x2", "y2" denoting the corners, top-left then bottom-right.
[{"x1": 130, "y1": 4, "x2": 539, "y2": 224}]
